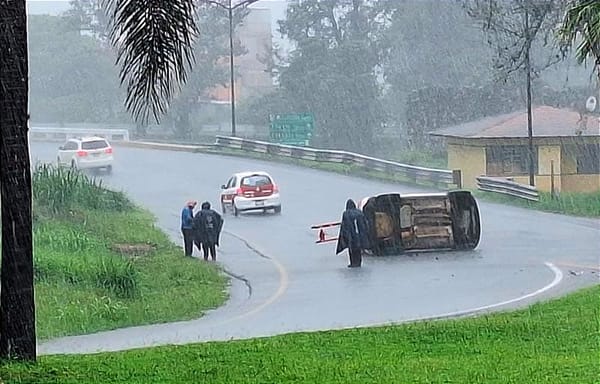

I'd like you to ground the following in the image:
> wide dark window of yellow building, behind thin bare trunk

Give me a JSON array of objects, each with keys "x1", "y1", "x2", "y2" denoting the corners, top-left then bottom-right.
[{"x1": 486, "y1": 145, "x2": 537, "y2": 176}]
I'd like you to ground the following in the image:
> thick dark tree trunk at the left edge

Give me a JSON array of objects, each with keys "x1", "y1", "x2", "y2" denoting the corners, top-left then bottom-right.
[{"x1": 0, "y1": 0, "x2": 36, "y2": 360}]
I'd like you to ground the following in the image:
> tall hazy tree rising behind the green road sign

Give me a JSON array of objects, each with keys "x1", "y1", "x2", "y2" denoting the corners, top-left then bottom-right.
[{"x1": 268, "y1": 0, "x2": 391, "y2": 151}]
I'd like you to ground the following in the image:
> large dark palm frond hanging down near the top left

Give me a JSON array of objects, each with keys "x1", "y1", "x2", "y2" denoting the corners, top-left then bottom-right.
[{"x1": 102, "y1": 0, "x2": 198, "y2": 122}]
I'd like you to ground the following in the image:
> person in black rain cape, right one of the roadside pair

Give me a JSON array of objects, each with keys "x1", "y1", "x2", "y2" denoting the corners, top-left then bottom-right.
[{"x1": 194, "y1": 201, "x2": 223, "y2": 261}]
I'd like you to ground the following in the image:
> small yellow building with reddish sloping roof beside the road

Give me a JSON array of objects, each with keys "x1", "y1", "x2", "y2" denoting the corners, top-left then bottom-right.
[{"x1": 430, "y1": 106, "x2": 600, "y2": 192}]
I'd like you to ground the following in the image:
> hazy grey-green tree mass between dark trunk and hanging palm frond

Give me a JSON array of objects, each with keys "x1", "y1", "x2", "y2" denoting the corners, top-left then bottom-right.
[{"x1": 28, "y1": 15, "x2": 130, "y2": 123}]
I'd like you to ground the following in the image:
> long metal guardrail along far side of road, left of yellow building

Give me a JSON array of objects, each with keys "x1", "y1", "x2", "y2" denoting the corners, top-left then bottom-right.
[{"x1": 215, "y1": 136, "x2": 462, "y2": 188}]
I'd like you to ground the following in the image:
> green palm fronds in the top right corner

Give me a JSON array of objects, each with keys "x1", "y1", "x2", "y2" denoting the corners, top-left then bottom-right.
[{"x1": 559, "y1": 0, "x2": 600, "y2": 82}]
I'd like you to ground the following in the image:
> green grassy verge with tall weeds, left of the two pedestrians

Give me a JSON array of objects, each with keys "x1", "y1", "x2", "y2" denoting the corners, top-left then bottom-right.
[{"x1": 33, "y1": 166, "x2": 227, "y2": 339}]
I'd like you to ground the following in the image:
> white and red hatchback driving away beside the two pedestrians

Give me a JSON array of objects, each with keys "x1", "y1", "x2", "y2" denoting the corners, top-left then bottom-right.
[{"x1": 221, "y1": 171, "x2": 281, "y2": 216}]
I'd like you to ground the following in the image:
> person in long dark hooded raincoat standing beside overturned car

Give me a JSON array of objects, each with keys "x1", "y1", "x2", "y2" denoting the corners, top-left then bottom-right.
[{"x1": 336, "y1": 199, "x2": 369, "y2": 268}]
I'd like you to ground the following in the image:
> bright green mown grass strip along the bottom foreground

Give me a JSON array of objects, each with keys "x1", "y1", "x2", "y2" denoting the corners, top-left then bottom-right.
[{"x1": 0, "y1": 286, "x2": 600, "y2": 384}]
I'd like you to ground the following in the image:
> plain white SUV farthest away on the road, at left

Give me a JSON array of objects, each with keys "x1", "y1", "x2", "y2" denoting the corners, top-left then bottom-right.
[{"x1": 56, "y1": 136, "x2": 113, "y2": 172}]
